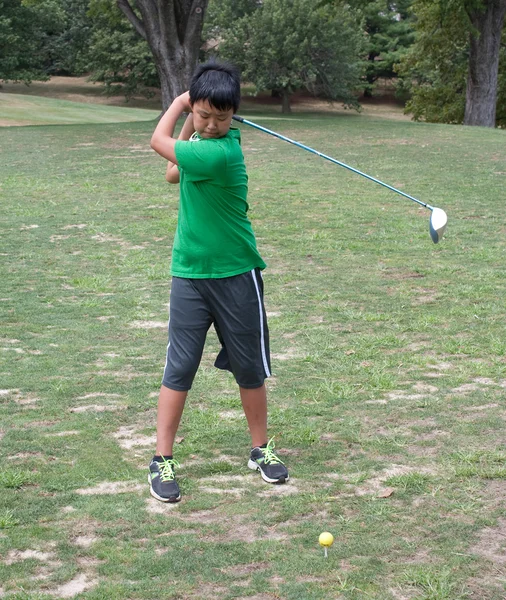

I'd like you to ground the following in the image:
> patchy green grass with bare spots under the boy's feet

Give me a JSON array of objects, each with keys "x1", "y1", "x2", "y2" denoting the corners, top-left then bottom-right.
[{"x1": 0, "y1": 90, "x2": 506, "y2": 600}]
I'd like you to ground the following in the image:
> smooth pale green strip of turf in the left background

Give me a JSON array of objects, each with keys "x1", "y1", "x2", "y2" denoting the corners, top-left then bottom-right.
[{"x1": 0, "y1": 93, "x2": 159, "y2": 125}]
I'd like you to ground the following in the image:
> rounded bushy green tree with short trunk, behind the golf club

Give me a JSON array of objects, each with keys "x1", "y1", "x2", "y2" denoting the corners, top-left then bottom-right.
[{"x1": 215, "y1": 0, "x2": 363, "y2": 112}]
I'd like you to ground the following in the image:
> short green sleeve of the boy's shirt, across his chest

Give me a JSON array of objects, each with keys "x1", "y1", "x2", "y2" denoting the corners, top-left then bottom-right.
[{"x1": 175, "y1": 139, "x2": 227, "y2": 181}]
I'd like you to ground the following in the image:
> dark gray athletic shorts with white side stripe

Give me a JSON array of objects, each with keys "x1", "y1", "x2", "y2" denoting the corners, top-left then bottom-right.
[{"x1": 162, "y1": 269, "x2": 271, "y2": 392}]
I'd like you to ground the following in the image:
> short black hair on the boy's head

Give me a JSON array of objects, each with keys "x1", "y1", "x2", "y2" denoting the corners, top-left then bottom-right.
[{"x1": 190, "y1": 59, "x2": 241, "y2": 112}]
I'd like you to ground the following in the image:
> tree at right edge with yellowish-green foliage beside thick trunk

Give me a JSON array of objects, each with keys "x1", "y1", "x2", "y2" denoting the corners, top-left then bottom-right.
[{"x1": 398, "y1": 0, "x2": 506, "y2": 127}]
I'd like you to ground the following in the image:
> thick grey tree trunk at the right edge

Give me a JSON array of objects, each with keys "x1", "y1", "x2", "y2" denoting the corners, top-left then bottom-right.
[{"x1": 464, "y1": 0, "x2": 506, "y2": 127}]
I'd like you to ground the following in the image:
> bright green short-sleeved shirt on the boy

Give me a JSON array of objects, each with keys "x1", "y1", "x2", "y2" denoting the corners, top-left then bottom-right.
[{"x1": 171, "y1": 128, "x2": 265, "y2": 279}]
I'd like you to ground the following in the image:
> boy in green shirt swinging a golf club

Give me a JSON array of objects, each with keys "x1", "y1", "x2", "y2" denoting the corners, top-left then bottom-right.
[{"x1": 149, "y1": 61, "x2": 289, "y2": 502}]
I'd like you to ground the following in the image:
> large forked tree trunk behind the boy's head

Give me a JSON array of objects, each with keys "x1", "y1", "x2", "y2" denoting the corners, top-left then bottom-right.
[{"x1": 117, "y1": 0, "x2": 208, "y2": 111}]
